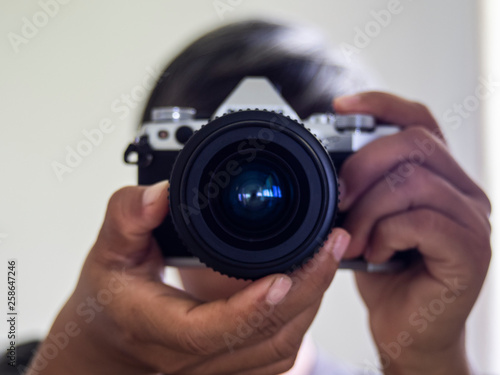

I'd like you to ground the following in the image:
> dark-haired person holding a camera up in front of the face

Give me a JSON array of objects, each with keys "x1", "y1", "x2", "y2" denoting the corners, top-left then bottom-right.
[{"x1": 27, "y1": 21, "x2": 491, "y2": 375}]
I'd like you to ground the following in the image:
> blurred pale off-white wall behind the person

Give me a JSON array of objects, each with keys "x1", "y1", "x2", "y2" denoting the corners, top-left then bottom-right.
[{"x1": 0, "y1": 0, "x2": 500, "y2": 374}]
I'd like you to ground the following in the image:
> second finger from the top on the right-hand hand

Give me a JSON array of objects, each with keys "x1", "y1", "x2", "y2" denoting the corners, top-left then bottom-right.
[{"x1": 339, "y1": 127, "x2": 491, "y2": 212}]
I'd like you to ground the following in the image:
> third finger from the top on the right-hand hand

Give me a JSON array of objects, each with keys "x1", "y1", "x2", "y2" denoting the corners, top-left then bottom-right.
[{"x1": 344, "y1": 166, "x2": 487, "y2": 257}]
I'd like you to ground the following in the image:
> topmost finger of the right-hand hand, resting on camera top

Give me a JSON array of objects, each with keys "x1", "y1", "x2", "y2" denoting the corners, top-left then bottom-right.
[{"x1": 333, "y1": 92, "x2": 444, "y2": 139}]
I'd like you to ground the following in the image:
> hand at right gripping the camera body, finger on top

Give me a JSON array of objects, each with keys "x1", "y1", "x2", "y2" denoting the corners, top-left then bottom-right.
[{"x1": 334, "y1": 92, "x2": 491, "y2": 375}]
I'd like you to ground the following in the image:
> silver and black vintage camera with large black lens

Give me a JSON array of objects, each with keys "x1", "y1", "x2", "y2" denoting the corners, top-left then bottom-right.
[{"x1": 124, "y1": 77, "x2": 406, "y2": 279}]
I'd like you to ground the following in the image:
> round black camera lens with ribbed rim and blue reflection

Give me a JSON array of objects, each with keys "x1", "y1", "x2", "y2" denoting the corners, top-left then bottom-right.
[{"x1": 170, "y1": 110, "x2": 337, "y2": 279}]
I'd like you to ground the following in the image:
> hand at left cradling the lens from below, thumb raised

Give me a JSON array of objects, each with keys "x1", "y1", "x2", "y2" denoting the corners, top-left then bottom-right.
[{"x1": 28, "y1": 182, "x2": 349, "y2": 375}]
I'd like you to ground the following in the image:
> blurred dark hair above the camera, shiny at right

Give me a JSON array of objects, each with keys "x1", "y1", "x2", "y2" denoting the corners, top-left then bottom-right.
[{"x1": 143, "y1": 20, "x2": 364, "y2": 121}]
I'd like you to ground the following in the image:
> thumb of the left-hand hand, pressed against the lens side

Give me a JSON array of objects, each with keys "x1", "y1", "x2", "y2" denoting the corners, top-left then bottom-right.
[{"x1": 93, "y1": 181, "x2": 169, "y2": 263}]
